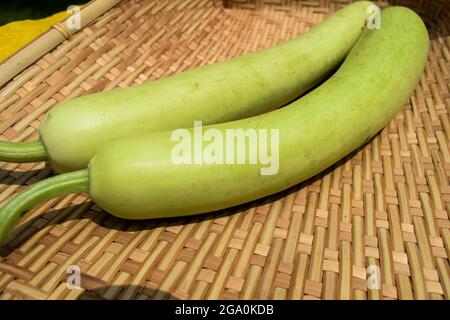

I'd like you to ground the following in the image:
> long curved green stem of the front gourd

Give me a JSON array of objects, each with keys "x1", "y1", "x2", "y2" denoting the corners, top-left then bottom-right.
[{"x1": 0, "y1": 169, "x2": 89, "y2": 245}]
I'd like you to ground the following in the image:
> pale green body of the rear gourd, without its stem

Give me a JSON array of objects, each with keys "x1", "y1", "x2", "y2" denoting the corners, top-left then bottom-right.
[{"x1": 39, "y1": 1, "x2": 371, "y2": 172}]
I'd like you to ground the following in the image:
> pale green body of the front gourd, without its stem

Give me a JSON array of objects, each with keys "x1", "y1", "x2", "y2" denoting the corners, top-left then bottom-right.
[{"x1": 89, "y1": 7, "x2": 429, "y2": 219}]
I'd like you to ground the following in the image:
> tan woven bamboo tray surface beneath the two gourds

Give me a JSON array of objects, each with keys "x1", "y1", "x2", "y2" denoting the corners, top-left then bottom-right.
[{"x1": 0, "y1": 0, "x2": 450, "y2": 299}]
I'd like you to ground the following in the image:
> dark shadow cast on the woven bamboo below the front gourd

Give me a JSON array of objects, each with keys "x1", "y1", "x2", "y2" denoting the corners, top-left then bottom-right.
[{"x1": 0, "y1": 134, "x2": 372, "y2": 257}]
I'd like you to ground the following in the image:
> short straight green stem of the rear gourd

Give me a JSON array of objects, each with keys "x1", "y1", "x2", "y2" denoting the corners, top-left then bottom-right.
[{"x1": 0, "y1": 139, "x2": 48, "y2": 163}]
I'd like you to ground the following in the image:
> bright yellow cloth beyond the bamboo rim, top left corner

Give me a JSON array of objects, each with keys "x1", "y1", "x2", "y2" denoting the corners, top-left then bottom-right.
[{"x1": 0, "y1": 11, "x2": 69, "y2": 61}]
